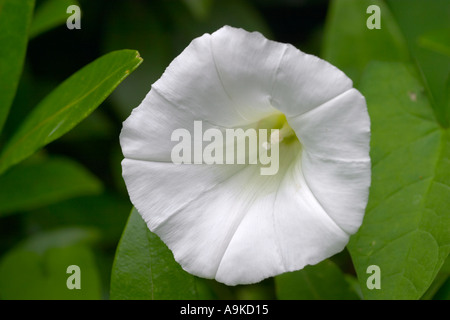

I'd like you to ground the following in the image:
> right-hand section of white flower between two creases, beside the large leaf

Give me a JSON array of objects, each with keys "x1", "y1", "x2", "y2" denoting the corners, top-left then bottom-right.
[{"x1": 288, "y1": 89, "x2": 370, "y2": 234}]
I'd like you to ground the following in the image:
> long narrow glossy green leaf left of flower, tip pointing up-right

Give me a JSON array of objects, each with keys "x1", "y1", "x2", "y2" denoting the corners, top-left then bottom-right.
[{"x1": 0, "y1": 50, "x2": 142, "y2": 173}]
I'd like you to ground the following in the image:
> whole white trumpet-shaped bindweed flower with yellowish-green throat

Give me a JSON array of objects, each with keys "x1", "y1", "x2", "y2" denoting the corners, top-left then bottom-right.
[{"x1": 120, "y1": 27, "x2": 370, "y2": 285}]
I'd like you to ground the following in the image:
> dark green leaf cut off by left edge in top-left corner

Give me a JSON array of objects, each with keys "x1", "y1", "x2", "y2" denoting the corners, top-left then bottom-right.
[{"x1": 0, "y1": 0, "x2": 34, "y2": 132}]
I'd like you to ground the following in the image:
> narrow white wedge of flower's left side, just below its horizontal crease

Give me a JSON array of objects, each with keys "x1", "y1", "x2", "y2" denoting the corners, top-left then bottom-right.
[{"x1": 122, "y1": 158, "x2": 244, "y2": 231}]
